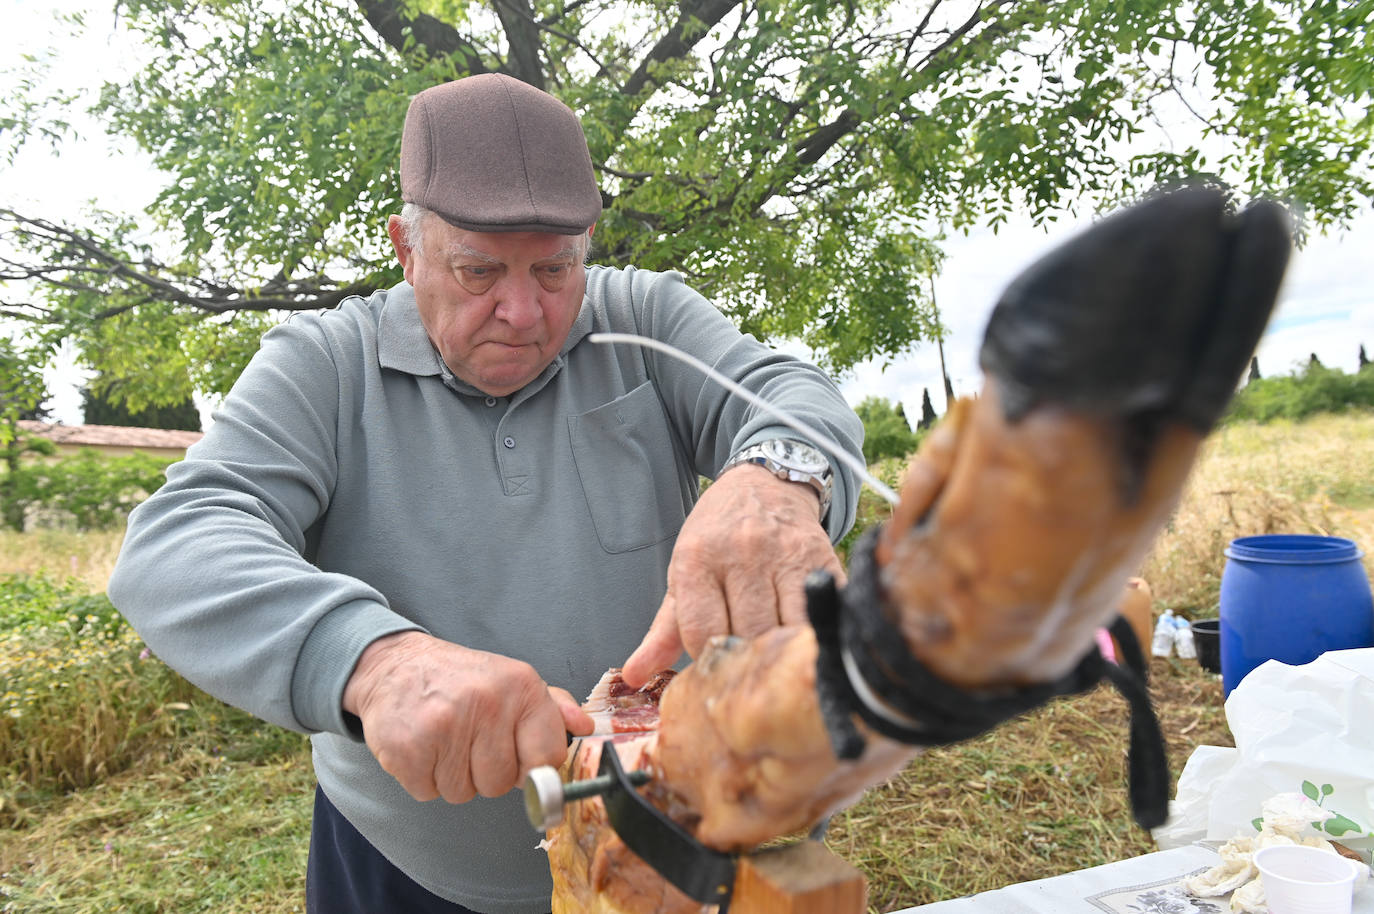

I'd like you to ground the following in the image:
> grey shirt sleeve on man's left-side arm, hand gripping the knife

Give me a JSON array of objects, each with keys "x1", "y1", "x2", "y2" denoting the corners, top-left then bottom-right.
[{"x1": 109, "y1": 311, "x2": 418, "y2": 739}]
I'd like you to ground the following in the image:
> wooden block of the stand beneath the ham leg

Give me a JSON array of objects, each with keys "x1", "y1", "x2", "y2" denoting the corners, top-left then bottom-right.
[{"x1": 730, "y1": 841, "x2": 868, "y2": 914}]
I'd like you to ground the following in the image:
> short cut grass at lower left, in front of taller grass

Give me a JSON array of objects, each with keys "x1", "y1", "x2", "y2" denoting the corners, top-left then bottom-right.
[{"x1": 0, "y1": 741, "x2": 313, "y2": 914}]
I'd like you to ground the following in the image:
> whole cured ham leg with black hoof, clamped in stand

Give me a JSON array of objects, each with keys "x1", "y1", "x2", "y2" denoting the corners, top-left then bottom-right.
[{"x1": 550, "y1": 191, "x2": 1290, "y2": 914}]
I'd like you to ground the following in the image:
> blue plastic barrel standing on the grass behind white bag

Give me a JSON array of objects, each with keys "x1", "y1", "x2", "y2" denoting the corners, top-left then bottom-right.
[{"x1": 1220, "y1": 533, "x2": 1374, "y2": 695}]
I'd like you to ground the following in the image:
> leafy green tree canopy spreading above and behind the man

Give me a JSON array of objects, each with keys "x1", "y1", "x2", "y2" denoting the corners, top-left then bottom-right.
[{"x1": 0, "y1": 0, "x2": 1374, "y2": 408}]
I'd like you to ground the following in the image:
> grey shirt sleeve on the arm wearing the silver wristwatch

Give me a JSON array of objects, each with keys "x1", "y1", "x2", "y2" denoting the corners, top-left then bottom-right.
[{"x1": 636, "y1": 274, "x2": 863, "y2": 543}]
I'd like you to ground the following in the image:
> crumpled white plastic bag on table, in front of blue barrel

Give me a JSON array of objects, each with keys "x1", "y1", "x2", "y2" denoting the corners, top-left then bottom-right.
[{"x1": 1154, "y1": 647, "x2": 1374, "y2": 863}]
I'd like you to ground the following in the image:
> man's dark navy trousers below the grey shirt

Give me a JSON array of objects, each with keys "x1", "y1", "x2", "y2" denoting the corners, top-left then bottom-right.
[{"x1": 305, "y1": 788, "x2": 480, "y2": 914}]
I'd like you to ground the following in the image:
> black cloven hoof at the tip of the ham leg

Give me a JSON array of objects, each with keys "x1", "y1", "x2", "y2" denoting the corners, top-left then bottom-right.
[{"x1": 981, "y1": 188, "x2": 1292, "y2": 432}]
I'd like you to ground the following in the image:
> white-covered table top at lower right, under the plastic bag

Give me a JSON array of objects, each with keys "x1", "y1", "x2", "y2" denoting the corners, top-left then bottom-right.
[{"x1": 892, "y1": 844, "x2": 1374, "y2": 914}]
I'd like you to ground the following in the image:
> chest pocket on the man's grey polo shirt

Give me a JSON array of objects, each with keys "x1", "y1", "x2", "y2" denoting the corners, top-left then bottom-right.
[{"x1": 567, "y1": 381, "x2": 687, "y2": 553}]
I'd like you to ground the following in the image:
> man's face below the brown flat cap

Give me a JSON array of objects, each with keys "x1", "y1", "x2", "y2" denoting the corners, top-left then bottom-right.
[{"x1": 387, "y1": 216, "x2": 587, "y2": 397}]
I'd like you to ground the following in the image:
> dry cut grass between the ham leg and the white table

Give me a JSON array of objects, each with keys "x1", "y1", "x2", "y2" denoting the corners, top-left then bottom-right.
[{"x1": 827, "y1": 660, "x2": 1234, "y2": 911}]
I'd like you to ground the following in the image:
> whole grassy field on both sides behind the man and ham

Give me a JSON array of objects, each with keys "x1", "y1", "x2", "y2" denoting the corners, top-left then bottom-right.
[{"x1": 0, "y1": 416, "x2": 1374, "y2": 914}]
